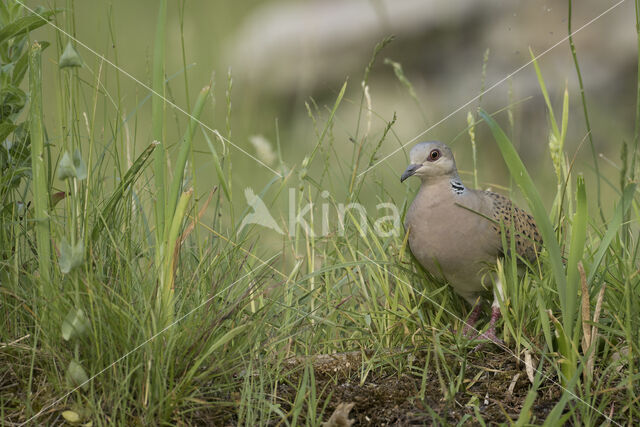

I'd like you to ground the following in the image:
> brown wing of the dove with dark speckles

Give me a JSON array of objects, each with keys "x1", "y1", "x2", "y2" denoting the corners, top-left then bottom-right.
[{"x1": 484, "y1": 191, "x2": 542, "y2": 262}]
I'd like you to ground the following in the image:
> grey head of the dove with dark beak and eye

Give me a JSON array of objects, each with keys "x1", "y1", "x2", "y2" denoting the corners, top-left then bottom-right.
[{"x1": 400, "y1": 141, "x2": 458, "y2": 182}]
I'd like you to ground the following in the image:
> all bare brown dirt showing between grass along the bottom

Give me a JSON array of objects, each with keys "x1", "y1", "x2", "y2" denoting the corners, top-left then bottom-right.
[{"x1": 0, "y1": 351, "x2": 624, "y2": 427}]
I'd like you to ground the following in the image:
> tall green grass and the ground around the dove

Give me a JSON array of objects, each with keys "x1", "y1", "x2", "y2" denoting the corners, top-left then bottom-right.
[{"x1": 0, "y1": 1, "x2": 640, "y2": 425}]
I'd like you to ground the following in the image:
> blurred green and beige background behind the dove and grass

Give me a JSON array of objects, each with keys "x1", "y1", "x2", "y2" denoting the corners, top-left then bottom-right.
[{"x1": 28, "y1": 0, "x2": 637, "y2": 227}]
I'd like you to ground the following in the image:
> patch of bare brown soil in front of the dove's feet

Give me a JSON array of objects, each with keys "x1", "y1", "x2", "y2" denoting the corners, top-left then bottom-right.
[{"x1": 279, "y1": 354, "x2": 561, "y2": 427}]
